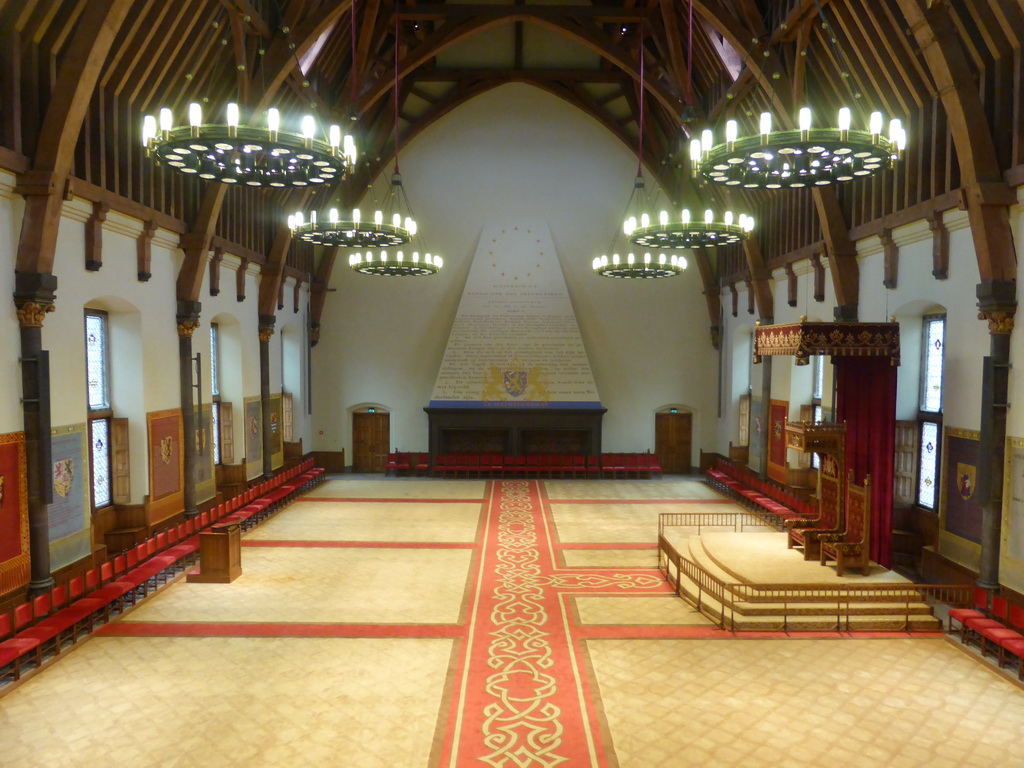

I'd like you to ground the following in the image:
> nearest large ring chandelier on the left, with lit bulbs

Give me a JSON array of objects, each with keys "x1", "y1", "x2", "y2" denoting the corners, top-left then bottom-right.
[{"x1": 142, "y1": 103, "x2": 355, "y2": 187}]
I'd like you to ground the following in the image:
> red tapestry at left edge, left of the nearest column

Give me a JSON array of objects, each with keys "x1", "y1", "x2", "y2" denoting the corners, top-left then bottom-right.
[{"x1": 0, "y1": 432, "x2": 31, "y2": 592}]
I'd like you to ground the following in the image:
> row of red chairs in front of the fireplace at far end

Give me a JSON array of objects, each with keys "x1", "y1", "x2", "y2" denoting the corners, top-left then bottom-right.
[{"x1": 385, "y1": 452, "x2": 662, "y2": 478}]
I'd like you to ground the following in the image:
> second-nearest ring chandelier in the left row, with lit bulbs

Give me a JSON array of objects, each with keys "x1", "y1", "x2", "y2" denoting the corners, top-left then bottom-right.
[{"x1": 288, "y1": 173, "x2": 417, "y2": 249}]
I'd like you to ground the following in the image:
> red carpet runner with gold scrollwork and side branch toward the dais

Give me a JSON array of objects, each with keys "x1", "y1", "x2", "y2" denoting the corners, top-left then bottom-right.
[{"x1": 441, "y1": 480, "x2": 669, "y2": 768}]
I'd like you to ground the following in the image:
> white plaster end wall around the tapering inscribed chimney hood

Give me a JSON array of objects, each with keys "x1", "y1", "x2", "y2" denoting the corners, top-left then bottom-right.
[{"x1": 312, "y1": 84, "x2": 718, "y2": 466}]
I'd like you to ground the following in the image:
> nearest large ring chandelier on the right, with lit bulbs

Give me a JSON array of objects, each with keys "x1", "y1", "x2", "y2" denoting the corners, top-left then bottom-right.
[{"x1": 690, "y1": 106, "x2": 906, "y2": 189}]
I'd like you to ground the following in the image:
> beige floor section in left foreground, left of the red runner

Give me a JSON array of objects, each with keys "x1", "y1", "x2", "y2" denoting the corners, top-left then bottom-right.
[{"x1": 0, "y1": 637, "x2": 453, "y2": 768}]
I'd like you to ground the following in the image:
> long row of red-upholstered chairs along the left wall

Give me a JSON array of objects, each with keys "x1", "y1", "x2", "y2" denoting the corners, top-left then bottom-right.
[{"x1": 0, "y1": 459, "x2": 325, "y2": 680}]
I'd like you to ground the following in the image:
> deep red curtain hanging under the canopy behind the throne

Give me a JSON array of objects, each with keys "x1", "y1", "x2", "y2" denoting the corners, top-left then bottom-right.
[{"x1": 833, "y1": 356, "x2": 897, "y2": 568}]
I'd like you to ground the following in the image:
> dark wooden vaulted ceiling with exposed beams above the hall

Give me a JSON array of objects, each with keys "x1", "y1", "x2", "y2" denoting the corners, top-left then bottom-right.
[{"x1": 0, "y1": 0, "x2": 1024, "y2": 321}]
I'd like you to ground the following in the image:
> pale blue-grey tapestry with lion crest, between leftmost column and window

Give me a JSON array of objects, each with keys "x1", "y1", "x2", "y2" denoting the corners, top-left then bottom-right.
[{"x1": 49, "y1": 424, "x2": 92, "y2": 570}]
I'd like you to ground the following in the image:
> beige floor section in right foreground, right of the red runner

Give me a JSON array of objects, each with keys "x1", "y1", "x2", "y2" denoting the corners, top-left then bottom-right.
[{"x1": 587, "y1": 639, "x2": 1024, "y2": 768}]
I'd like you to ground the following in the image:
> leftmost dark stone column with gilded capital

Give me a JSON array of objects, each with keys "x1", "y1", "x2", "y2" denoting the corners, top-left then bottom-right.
[{"x1": 14, "y1": 272, "x2": 57, "y2": 597}]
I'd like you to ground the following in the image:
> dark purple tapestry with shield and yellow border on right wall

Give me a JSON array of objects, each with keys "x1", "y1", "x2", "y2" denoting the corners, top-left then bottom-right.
[{"x1": 939, "y1": 434, "x2": 981, "y2": 569}]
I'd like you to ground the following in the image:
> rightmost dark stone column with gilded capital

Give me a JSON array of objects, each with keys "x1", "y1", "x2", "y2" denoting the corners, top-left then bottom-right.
[{"x1": 976, "y1": 281, "x2": 1017, "y2": 590}]
